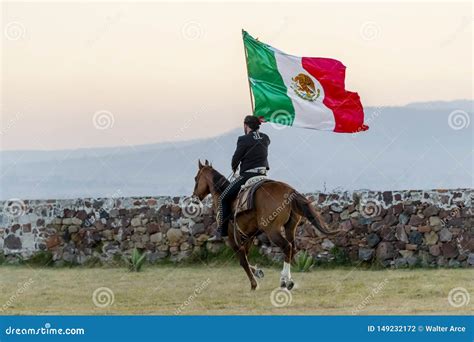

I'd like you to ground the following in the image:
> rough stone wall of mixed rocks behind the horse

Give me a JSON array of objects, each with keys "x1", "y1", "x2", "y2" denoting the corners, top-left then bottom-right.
[{"x1": 0, "y1": 189, "x2": 474, "y2": 267}]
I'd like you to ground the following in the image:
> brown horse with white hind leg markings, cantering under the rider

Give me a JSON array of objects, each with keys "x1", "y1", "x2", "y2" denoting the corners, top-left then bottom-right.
[{"x1": 193, "y1": 160, "x2": 335, "y2": 290}]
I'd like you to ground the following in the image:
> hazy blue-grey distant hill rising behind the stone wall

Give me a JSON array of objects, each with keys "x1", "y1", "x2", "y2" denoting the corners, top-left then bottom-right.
[{"x1": 0, "y1": 100, "x2": 474, "y2": 199}]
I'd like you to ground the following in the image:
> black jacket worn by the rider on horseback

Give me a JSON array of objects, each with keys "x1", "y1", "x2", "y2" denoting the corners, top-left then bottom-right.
[{"x1": 232, "y1": 130, "x2": 270, "y2": 172}]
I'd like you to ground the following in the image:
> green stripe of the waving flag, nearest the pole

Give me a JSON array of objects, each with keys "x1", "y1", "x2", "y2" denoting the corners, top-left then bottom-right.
[{"x1": 242, "y1": 31, "x2": 295, "y2": 126}]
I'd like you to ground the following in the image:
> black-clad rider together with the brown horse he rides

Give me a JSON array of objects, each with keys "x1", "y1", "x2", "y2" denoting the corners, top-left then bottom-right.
[{"x1": 193, "y1": 116, "x2": 338, "y2": 290}]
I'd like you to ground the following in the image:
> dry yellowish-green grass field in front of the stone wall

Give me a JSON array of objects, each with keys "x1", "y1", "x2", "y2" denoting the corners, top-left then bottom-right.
[{"x1": 0, "y1": 264, "x2": 474, "y2": 315}]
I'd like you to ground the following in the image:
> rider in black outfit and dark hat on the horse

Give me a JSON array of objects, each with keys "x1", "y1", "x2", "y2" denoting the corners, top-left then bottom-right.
[{"x1": 209, "y1": 115, "x2": 270, "y2": 241}]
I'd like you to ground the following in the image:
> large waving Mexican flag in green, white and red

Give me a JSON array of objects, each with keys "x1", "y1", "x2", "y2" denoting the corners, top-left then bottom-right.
[{"x1": 242, "y1": 31, "x2": 369, "y2": 133}]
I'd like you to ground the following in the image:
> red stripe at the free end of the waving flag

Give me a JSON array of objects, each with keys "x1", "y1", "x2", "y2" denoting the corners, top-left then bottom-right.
[{"x1": 301, "y1": 57, "x2": 369, "y2": 133}]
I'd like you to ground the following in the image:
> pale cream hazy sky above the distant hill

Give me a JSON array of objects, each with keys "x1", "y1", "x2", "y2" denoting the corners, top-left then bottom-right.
[{"x1": 0, "y1": 2, "x2": 473, "y2": 150}]
